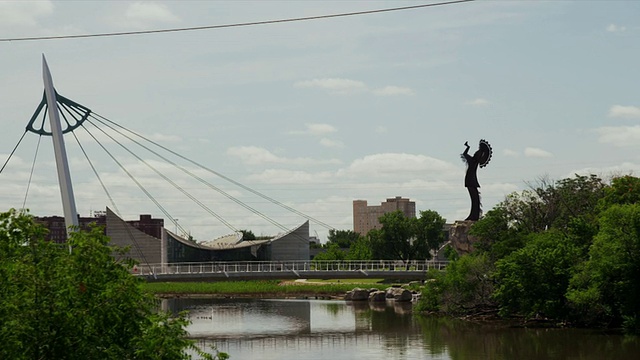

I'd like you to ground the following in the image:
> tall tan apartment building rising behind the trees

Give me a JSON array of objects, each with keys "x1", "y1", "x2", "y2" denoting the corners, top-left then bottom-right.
[{"x1": 353, "y1": 196, "x2": 416, "y2": 235}]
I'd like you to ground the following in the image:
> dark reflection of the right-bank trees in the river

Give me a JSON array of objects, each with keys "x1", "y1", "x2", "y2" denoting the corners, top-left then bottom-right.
[{"x1": 417, "y1": 316, "x2": 640, "y2": 360}]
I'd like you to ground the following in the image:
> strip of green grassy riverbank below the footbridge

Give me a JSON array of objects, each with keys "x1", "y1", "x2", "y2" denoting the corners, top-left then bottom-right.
[{"x1": 143, "y1": 280, "x2": 389, "y2": 297}]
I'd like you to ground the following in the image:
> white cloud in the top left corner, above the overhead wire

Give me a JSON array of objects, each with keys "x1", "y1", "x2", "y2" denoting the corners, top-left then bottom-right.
[{"x1": 0, "y1": 1, "x2": 54, "y2": 27}]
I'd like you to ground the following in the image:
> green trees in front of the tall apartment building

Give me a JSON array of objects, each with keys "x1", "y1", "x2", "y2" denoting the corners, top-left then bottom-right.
[{"x1": 367, "y1": 211, "x2": 445, "y2": 261}]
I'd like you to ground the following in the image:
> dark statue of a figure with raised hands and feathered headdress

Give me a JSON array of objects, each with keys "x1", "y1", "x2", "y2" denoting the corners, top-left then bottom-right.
[{"x1": 461, "y1": 139, "x2": 493, "y2": 221}]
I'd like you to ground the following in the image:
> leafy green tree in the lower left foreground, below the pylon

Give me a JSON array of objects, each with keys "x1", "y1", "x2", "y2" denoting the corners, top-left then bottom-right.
[{"x1": 0, "y1": 210, "x2": 227, "y2": 359}]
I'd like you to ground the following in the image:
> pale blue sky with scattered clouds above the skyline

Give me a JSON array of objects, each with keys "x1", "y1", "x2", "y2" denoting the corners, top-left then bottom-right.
[{"x1": 0, "y1": 0, "x2": 640, "y2": 241}]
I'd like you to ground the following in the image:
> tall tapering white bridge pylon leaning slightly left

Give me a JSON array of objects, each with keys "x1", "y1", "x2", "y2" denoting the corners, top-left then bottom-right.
[{"x1": 42, "y1": 54, "x2": 78, "y2": 237}]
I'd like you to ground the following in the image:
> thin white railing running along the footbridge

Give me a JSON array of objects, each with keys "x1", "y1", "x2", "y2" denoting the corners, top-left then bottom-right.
[{"x1": 134, "y1": 260, "x2": 447, "y2": 275}]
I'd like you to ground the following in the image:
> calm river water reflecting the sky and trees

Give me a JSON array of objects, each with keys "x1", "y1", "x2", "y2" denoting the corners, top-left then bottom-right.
[{"x1": 164, "y1": 299, "x2": 640, "y2": 360}]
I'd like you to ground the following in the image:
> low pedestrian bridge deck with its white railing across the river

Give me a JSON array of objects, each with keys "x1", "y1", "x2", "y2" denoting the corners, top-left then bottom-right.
[{"x1": 138, "y1": 260, "x2": 447, "y2": 282}]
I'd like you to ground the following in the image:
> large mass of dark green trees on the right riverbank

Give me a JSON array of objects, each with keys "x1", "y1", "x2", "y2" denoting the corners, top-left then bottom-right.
[{"x1": 420, "y1": 175, "x2": 640, "y2": 333}]
